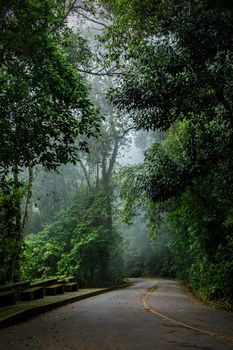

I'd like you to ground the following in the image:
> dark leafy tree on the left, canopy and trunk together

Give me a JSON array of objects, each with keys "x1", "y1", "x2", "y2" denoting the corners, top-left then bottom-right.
[{"x1": 0, "y1": 0, "x2": 100, "y2": 283}]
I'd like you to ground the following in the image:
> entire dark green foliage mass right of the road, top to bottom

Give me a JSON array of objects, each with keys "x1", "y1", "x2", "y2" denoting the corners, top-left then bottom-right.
[{"x1": 103, "y1": 0, "x2": 233, "y2": 303}]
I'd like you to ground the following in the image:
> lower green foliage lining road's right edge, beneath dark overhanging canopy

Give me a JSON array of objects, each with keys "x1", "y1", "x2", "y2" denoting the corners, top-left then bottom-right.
[{"x1": 118, "y1": 123, "x2": 233, "y2": 305}]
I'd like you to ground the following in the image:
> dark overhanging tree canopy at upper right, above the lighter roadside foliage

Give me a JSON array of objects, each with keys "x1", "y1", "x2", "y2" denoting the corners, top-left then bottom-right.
[{"x1": 99, "y1": 0, "x2": 233, "y2": 201}]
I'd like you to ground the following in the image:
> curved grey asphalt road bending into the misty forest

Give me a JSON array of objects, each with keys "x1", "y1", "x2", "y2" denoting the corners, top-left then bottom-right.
[{"x1": 0, "y1": 279, "x2": 233, "y2": 350}]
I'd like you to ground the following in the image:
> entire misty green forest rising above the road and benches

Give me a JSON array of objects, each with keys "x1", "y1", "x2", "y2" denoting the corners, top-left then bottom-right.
[{"x1": 0, "y1": 0, "x2": 233, "y2": 309}]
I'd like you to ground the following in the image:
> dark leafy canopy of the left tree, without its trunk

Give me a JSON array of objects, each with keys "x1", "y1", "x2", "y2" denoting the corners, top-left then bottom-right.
[{"x1": 0, "y1": 0, "x2": 98, "y2": 169}]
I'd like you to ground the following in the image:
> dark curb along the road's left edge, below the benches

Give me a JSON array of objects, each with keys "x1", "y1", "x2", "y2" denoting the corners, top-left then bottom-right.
[{"x1": 0, "y1": 283, "x2": 131, "y2": 329}]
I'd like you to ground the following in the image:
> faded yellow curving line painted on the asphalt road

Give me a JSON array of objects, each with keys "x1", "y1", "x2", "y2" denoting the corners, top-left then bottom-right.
[{"x1": 142, "y1": 286, "x2": 233, "y2": 342}]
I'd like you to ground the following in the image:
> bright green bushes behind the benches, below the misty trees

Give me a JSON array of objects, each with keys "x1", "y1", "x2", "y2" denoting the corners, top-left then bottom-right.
[{"x1": 21, "y1": 187, "x2": 123, "y2": 287}]
